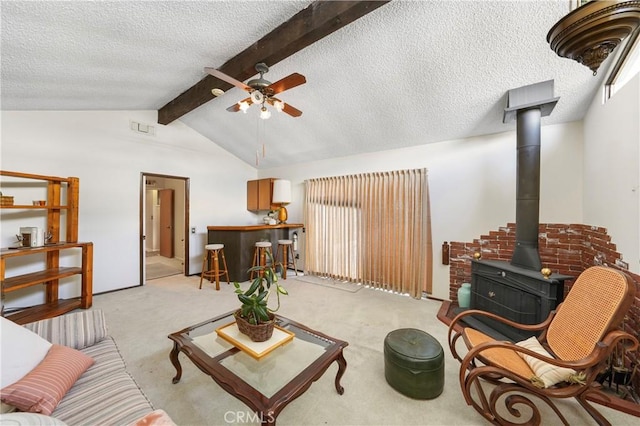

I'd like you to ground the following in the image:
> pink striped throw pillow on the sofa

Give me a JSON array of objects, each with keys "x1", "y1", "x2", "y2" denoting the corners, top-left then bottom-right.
[{"x1": 0, "y1": 345, "x2": 94, "y2": 416}]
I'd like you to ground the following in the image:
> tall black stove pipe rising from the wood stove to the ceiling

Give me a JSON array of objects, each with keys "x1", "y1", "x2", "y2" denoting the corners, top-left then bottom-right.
[{"x1": 503, "y1": 80, "x2": 560, "y2": 271}]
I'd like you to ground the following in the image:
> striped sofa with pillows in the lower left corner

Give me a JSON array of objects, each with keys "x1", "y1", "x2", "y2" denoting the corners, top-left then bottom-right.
[{"x1": 0, "y1": 310, "x2": 175, "y2": 425}]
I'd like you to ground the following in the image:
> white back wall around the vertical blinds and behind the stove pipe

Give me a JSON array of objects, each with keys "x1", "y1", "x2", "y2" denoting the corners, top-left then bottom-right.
[{"x1": 259, "y1": 118, "x2": 583, "y2": 299}]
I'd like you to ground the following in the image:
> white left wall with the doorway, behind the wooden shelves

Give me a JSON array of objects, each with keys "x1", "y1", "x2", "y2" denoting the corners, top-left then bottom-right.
[{"x1": 0, "y1": 111, "x2": 257, "y2": 306}]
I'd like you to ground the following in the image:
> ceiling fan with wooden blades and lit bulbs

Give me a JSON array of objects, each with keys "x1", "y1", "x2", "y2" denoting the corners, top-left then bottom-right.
[{"x1": 204, "y1": 62, "x2": 307, "y2": 119}]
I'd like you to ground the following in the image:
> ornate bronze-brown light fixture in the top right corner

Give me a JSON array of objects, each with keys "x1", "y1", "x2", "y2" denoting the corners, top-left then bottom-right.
[{"x1": 547, "y1": 0, "x2": 640, "y2": 75}]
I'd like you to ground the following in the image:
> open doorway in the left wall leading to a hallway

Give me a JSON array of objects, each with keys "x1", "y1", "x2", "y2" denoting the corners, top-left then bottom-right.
[{"x1": 140, "y1": 172, "x2": 189, "y2": 285}]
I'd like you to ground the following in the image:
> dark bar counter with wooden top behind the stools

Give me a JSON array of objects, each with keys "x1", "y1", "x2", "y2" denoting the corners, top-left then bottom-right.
[{"x1": 207, "y1": 223, "x2": 304, "y2": 282}]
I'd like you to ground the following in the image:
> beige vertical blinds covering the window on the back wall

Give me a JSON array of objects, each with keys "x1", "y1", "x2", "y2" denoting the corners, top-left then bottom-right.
[{"x1": 304, "y1": 169, "x2": 433, "y2": 298}]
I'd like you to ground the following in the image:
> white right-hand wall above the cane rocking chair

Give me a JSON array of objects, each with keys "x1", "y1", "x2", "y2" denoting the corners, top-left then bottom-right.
[{"x1": 583, "y1": 74, "x2": 640, "y2": 274}]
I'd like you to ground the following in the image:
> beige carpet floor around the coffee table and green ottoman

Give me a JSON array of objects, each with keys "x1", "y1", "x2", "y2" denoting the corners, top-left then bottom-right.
[{"x1": 93, "y1": 275, "x2": 638, "y2": 426}]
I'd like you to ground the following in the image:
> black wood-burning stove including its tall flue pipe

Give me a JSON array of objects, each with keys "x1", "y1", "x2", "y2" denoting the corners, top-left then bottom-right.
[{"x1": 462, "y1": 80, "x2": 572, "y2": 341}]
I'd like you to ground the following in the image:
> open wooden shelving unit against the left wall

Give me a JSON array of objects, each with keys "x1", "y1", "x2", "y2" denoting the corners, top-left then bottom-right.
[{"x1": 0, "y1": 170, "x2": 93, "y2": 324}]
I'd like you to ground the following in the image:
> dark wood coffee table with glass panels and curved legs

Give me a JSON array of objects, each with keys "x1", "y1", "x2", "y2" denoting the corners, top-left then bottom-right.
[{"x1": 169, "y1": 311, "x2": 349, "y2": 425}]
